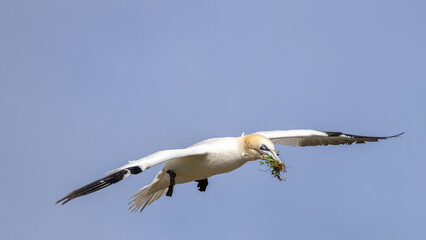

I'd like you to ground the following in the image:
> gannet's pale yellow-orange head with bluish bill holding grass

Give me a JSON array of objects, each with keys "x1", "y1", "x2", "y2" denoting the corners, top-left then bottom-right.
[{"x1": 243, "y1": 134, "x2": 282, "y2": 163}]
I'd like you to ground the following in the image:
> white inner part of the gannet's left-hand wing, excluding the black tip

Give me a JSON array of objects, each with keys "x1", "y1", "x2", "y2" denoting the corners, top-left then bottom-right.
[{"x1": 108, "y1": 146, "x2": 207, "y2": 174}]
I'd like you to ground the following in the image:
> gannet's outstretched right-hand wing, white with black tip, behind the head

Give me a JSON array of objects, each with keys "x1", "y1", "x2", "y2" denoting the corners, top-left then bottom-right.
[{"x1": 255, "y1": 129, "x2": 403, "y2": 147}]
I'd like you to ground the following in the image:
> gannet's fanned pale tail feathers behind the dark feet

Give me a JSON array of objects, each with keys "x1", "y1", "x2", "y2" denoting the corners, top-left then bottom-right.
[{"x1": 129, "y1": 179, "x2": 167, "y2": 213}]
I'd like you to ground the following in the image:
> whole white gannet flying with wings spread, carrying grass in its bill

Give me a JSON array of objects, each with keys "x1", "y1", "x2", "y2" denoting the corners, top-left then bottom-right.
[{"x1": 56, "y1": 130, "x2": 403, "y2": 212}]
